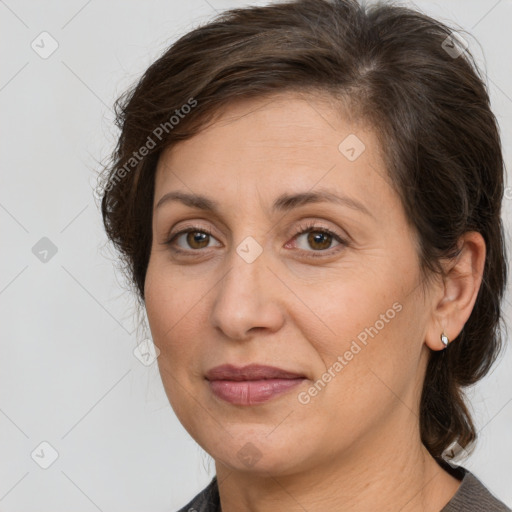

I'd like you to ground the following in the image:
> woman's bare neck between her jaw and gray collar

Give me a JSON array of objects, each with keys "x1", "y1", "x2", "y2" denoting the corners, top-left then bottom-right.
[{"x1": 216, "y1": 408, "x2": 460, "y2": 512}]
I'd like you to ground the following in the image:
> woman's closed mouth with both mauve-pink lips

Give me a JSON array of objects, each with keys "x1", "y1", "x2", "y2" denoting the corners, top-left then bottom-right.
[{"x1": 206, "y1": 364, "x2": 306, "y2": 406}]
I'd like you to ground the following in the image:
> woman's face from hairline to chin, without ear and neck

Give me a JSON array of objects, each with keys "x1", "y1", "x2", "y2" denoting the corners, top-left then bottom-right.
[{"x1": 145, "y1": 93, "x2": 438, "y2": 474}]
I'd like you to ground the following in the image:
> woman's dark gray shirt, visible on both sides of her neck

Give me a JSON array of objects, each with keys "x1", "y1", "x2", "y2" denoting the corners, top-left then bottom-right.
[{"x1": 178, "y1": 466, "x2": 512, "y2": 512}]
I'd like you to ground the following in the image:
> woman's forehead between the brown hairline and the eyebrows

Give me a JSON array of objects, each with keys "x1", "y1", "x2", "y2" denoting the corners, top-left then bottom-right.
[{"x1": 155, "y1": 93, "x2": 387, "y2": 209}]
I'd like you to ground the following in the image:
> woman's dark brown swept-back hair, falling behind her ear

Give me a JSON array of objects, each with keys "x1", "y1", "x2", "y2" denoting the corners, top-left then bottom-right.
[{"x1": 98, "y1": 0, "x2": 507, "y2": 458}]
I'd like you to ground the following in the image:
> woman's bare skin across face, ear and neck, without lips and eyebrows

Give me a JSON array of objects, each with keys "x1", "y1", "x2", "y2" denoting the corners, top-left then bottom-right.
[{"x1": 145, "y1": 93, "x2": 485, "y2": 512}]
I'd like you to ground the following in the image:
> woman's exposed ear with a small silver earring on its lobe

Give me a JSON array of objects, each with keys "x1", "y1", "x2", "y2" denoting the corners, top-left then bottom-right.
[{"x1": 425, "y1": 231, "x2": 486, "y2": 350}]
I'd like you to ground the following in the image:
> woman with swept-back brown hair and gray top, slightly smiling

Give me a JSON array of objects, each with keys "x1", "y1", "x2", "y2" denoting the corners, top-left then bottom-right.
[{"x1": 98, "y1": 0, "x2": 510, "y2": 512}]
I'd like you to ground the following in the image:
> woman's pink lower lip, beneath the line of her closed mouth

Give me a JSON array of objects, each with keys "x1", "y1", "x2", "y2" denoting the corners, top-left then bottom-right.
[{"x1": 209, "y1": 378, "x2": 305, "y2": 405}]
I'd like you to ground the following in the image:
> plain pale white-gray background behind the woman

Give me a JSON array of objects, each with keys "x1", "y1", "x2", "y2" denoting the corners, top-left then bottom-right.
[{"x1": 0, "y1": 0, "x2": 512, "y2": 512}]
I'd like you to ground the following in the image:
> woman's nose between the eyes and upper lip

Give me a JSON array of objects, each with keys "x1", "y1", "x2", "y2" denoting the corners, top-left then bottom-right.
[{"x1": 210, "y1": 246, "x2": 285, "y2": 340}]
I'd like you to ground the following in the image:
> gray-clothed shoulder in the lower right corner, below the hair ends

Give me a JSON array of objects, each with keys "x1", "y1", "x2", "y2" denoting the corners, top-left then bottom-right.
[{"x1": 441, "y1": 467, "x2": 512, "y2": 512}]
